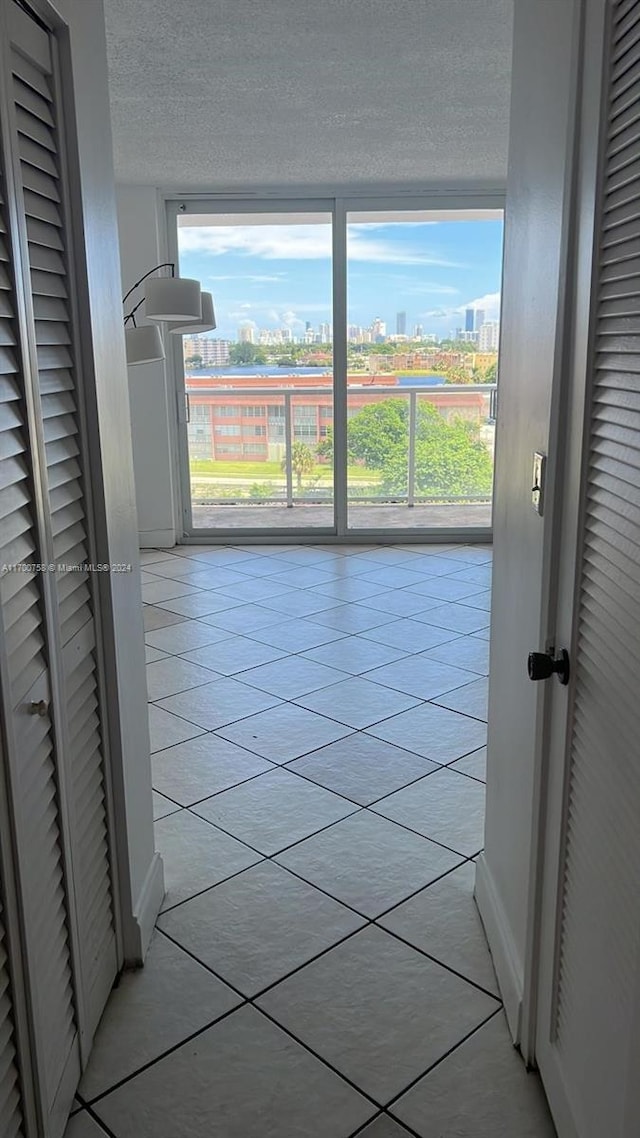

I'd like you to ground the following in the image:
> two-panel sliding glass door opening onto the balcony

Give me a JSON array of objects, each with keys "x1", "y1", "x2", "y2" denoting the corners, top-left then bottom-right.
[{"x1": 169, "y1": 199, "x2": 502, "y2": 541}]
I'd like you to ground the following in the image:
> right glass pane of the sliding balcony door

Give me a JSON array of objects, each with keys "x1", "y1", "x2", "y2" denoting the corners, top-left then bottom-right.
[{"x1": 347, "y1": 211, "x2": 502, "y2": 529}]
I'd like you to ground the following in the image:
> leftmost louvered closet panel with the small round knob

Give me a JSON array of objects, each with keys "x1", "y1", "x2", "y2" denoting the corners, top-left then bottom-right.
[{"x1": 0, "y1": 102, "x2": 80, "y2": 1133}]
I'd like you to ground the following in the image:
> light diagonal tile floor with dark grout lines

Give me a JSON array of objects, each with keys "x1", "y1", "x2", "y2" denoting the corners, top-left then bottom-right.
[{"x1": 67, "y1": 545, "x2": 553, "y2": 1138}]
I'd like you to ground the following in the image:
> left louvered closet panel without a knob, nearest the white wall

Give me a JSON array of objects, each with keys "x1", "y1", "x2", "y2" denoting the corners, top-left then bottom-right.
[{"x1": 6, "y1": 8, "x2": 117, "y2": 1036}]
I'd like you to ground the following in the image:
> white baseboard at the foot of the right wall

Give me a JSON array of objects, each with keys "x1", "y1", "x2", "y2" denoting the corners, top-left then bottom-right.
[{"x1": 475, "y1": 854, "x2": 524, "y2": 1044}]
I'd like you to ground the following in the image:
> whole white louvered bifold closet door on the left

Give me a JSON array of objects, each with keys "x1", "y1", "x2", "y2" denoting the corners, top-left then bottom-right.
[{"x1": 0, "y1": 0, "x2": 118, "y2": 1138}]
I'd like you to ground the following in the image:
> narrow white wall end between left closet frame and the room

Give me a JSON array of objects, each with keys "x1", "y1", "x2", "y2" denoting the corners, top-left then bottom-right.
[{"x1": 57, "y1": 0, "x2": 164, "y2": 963}]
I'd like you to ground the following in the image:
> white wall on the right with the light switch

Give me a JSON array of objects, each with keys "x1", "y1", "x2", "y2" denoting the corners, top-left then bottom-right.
[{"x1": 476, "y1": 0, "x2": 581, "y2": 1039}]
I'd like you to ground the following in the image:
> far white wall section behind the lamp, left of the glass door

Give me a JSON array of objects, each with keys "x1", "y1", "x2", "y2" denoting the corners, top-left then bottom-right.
[{"x1": 116, "y1": 185, "x2": 180, "y2": 547}]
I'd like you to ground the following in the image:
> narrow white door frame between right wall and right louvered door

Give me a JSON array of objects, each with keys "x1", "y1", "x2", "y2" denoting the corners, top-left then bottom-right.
[{"x1": 520, "y1": 0, "x2": 612, "y2": 1119}]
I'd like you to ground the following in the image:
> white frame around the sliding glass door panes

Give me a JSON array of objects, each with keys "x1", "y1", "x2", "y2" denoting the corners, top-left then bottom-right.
[{"x1": 163, "y1": 188, "x2": 506, "y2": 545}]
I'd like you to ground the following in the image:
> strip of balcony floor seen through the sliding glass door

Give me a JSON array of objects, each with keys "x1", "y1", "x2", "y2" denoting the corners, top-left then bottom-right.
[{"x1": 189, "y1": 503, "x2": 491, "y2": 533}]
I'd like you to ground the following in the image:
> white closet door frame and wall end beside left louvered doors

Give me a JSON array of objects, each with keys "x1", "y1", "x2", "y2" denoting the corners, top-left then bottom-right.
[{"x1": 11, "y1": 0, "x2": 164, "y2": 971}]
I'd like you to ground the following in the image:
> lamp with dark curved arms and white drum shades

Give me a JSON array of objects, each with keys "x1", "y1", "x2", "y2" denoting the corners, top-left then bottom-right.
[{"x1": 122, "y1": 261, "x2": 215, "y2": 366}]
